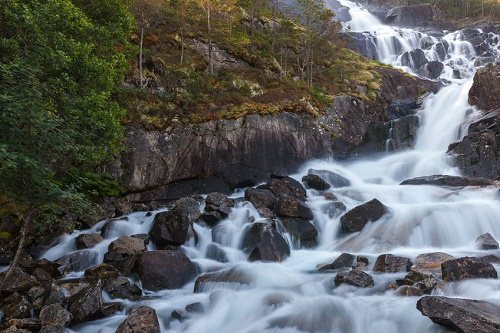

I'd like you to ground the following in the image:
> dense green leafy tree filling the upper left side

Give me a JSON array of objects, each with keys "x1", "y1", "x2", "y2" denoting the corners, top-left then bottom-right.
[{"x1": 0, "y1": 0, "x2": 133, "y2": 281}]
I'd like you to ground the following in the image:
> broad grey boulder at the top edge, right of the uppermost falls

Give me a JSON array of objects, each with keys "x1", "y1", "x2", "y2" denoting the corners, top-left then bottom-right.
[{"x1": 385, "y1": 4, "x2": 434, "y2": 27}]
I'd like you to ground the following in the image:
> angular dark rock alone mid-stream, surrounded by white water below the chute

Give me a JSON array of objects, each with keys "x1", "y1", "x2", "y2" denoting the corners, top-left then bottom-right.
[{"x1": 340, "y1": 199, "x2": 389, "y2": 233}]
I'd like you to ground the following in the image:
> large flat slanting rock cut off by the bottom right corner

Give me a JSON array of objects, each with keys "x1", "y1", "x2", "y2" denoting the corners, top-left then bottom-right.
[{"x1": 417, "y1": 296, "x2": 500, "y2": 333}]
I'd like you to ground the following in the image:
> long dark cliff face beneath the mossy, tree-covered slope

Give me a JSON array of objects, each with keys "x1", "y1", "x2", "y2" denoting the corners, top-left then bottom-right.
[{"x1": 113, "y1": 69, "x2": 437, "y2": 201}]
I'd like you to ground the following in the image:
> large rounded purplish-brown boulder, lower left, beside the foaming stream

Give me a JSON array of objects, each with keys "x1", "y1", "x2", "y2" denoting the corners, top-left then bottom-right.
[{"x1": 137, "y1": 250, "x2": 197, "y2": 290}]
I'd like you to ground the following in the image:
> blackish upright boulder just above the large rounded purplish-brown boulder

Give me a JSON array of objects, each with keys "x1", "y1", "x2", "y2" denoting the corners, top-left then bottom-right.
[{"x1": 149, "y1": 208, "x2": 191, "y2": 249}]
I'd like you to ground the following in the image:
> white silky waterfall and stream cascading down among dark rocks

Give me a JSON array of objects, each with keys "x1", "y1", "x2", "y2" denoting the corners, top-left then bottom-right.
[{"x1": 43, "y1": 1, "x2": 500, "y2": 333}]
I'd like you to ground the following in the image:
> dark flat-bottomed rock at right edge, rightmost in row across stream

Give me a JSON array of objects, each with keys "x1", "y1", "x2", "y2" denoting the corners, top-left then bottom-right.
[{"x1": 441, "y1": 257, "x2": 498, "y2": 282}]
